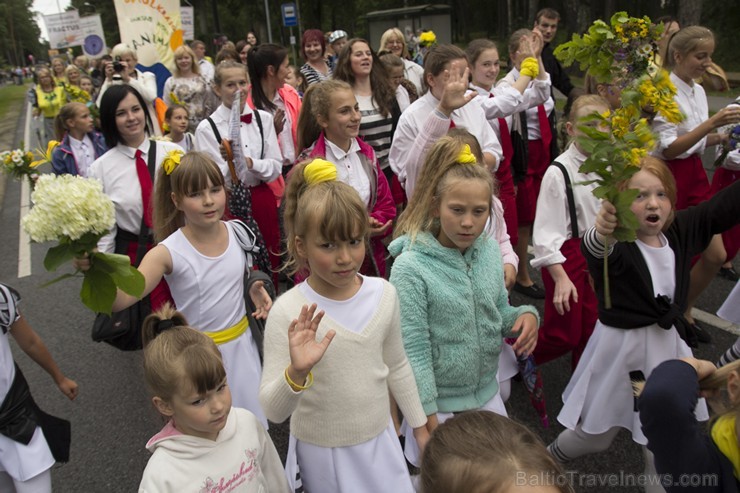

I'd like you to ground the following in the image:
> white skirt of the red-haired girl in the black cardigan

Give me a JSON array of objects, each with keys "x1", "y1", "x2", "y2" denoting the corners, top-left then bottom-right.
[{"x1": 558, "y1": 321, "x2": 709, "y2": 445}]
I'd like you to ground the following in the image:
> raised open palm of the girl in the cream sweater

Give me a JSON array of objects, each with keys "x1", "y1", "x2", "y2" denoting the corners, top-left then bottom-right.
[{"x1": 288, "y1": 303, "x2": 336, "y2": 374}]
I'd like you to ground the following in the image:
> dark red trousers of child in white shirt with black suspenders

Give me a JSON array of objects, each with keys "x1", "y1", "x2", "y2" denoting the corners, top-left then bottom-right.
[{"x1": 534, "y1": 238, "x2": 599, "y2": 370}]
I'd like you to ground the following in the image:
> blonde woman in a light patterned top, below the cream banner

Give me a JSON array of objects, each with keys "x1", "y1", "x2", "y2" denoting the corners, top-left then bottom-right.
[{"x1": 162, "y1": 45, "x2": 216, "y2": 132}]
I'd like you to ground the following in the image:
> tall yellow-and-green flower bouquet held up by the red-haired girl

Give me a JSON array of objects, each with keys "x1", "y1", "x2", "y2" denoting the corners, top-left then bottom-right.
[{"x1": 555, "y1": 12, "x2": 683, "y2": 308}]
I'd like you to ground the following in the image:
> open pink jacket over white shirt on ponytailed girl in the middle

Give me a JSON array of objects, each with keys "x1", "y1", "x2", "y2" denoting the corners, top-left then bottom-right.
[{"x1": 298, "y1": 132, "x2": 396, "y2": 277}]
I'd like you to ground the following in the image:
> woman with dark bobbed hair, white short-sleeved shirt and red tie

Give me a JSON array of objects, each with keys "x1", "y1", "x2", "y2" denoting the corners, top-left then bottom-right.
[{"x1": 88, "y1": 84, "x2": 181, "y2": 310}]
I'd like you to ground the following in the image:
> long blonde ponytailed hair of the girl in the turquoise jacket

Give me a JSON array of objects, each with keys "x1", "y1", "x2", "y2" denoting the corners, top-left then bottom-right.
[{"x1": 393, "y1": 135, "x2": 494, "y2": 241}]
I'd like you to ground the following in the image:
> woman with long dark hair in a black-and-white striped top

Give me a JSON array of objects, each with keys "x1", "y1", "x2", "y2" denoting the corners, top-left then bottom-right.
[{"x1": 334, "y1": 38, "x2": 401, "y2": 182}]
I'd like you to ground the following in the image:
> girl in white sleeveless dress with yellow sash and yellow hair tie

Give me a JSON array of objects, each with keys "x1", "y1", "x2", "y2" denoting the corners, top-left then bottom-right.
[{"x1": 105, "y1": 152, "x2": 272, "y2": 428}]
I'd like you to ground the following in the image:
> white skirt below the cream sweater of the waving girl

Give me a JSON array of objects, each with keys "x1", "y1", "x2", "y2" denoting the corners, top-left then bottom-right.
[{"x1": 285, "y1": 421, "x2": 414, "y2": 493}]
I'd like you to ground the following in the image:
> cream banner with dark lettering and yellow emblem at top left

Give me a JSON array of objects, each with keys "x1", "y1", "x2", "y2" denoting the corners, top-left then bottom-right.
[{"x1": 114, "y1": 0, "x2": 183, "y2": 71}]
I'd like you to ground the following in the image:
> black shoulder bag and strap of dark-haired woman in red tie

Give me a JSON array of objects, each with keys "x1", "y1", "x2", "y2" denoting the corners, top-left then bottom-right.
[{"x1": 91, "y1": 141, "x2": 157, "y2": 351}]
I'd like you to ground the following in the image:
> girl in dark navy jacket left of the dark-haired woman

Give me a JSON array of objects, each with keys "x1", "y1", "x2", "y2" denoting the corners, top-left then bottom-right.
[{"x1": 51, "y1": 103, "x2": 108, "y2": 177}]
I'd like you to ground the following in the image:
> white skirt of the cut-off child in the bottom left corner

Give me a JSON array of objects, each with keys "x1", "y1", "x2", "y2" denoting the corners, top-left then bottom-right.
[{"x1": 0, "y1": 426, "x2": 54, "y2": 481}]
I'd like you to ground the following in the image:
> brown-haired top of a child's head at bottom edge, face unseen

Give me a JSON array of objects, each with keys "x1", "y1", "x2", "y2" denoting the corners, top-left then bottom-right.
[{"x1": 420, "y1": 411, "x2": 573, "y2": 493}]
